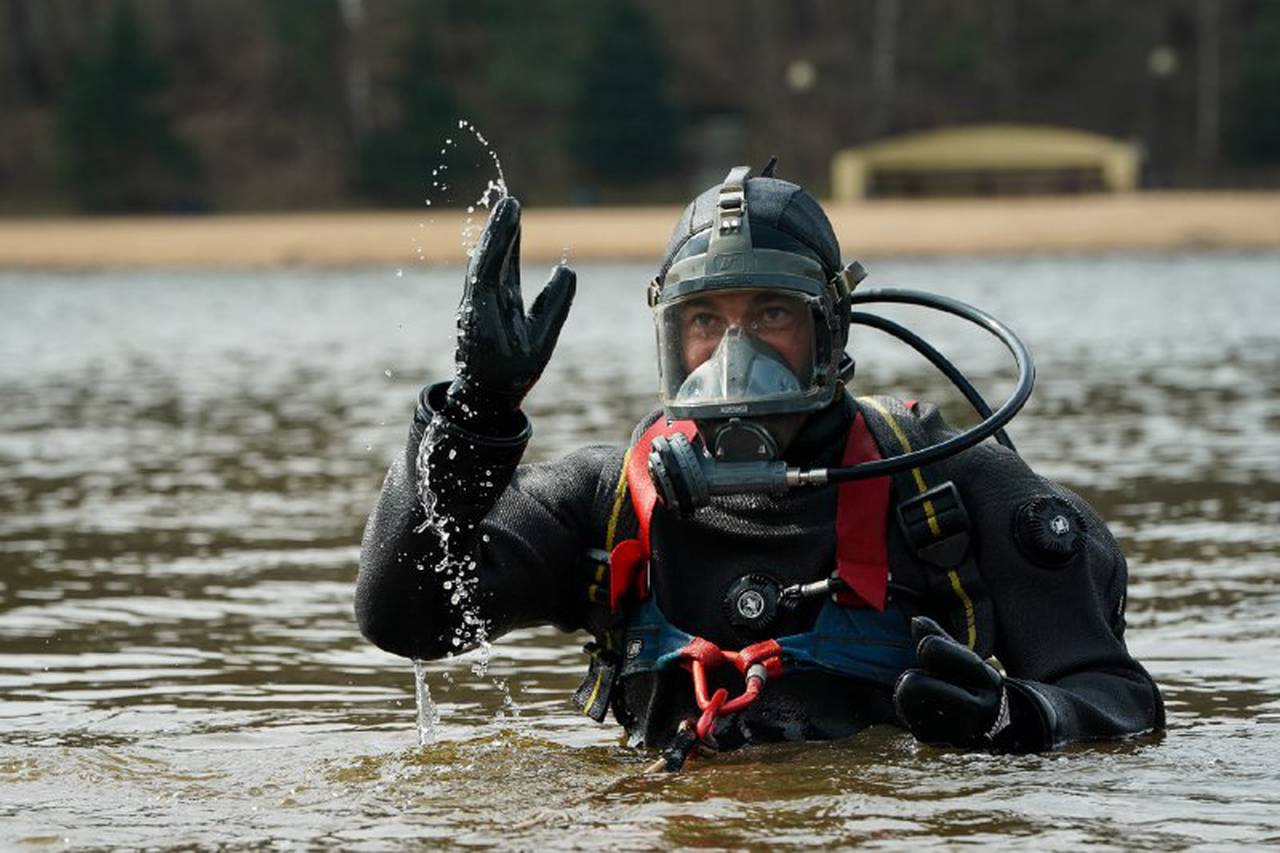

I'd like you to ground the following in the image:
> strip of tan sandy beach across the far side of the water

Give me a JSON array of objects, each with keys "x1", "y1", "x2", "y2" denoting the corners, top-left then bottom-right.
[{"x1": 0, "y1": 192, "x2": 1280, "y2": 269}]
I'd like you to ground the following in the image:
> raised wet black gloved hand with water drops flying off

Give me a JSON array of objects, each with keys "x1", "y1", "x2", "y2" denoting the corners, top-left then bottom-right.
[{"x1": 442, "y1": 196, "x2": 577, "y2": 432}]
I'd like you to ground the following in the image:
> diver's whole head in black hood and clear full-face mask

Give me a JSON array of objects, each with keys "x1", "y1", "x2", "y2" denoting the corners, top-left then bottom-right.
[{"x1": 649, "y1": 167, "x2": 860, "y2": 461}]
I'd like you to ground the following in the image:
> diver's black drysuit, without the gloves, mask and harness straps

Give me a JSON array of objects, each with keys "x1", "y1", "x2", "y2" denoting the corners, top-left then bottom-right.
[{"x1": 356, "y1": 386, "x2": 1164, "y2": 751}]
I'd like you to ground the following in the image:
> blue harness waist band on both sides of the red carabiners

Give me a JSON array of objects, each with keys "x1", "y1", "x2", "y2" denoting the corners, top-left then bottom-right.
[{"x1": 620, "y1": 596, "x2": 915, "y2": 685}]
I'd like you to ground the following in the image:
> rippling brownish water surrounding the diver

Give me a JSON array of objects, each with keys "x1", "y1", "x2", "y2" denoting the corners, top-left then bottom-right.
[{"x1": 0, "y1": 255, "x2": 1280, "y2": 849}]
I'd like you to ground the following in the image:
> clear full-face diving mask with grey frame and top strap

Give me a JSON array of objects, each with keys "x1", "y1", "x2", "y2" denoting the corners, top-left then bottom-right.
[{"x1": 649, "y1": 167, "x2": 855, "y2": 460}]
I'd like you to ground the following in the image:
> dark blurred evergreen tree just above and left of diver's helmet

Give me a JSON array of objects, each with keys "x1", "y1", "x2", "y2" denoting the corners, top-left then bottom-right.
[{"x1": 568, "y1": 0, "x2": 680, "y2": 186}]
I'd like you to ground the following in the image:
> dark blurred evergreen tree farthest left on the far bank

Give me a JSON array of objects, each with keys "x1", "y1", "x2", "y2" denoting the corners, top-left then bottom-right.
[{"x1": 58, "y1": 0, "x2": 198, "y2": 211}]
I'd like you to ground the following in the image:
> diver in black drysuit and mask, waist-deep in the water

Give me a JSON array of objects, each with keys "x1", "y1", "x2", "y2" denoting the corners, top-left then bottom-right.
[{"x1": 356, "y1": 163, "x2": 1165, "y2": 768}]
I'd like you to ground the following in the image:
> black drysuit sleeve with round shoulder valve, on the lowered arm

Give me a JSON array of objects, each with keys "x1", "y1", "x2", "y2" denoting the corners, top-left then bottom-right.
[{"x1": 931, "y1": 409, "x2": 1165, "y2": 751}]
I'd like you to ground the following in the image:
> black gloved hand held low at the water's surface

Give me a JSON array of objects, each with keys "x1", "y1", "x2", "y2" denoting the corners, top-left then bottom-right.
[{"x1": 893, "y1": 616, "x2": 1010, "y2": 747}]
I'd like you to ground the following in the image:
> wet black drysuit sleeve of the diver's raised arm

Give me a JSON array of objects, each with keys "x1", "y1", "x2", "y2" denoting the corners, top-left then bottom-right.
[{"x1": 356, "y1": 384, "x2": 622, "y2": 660}]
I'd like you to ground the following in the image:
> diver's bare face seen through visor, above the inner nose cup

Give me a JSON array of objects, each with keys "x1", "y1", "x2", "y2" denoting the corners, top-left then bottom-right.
[{"x1": 680, "y1": 291, "x2": 813, "y2": 375}]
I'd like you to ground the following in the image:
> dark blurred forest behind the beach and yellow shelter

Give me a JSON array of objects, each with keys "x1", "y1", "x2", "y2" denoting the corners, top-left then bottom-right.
[{"x1": 0, "y1": 0, "x2": 1280, "y2": 214}]
